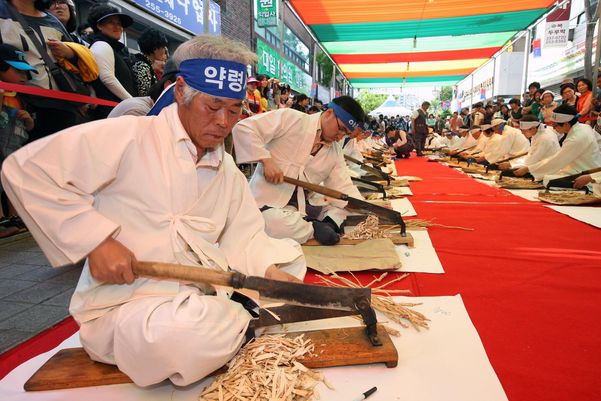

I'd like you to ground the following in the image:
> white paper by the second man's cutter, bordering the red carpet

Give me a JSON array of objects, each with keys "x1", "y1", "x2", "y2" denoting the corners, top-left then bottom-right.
[{"x1": 395, "y1": 230, "x2": 444, "y2": 274}]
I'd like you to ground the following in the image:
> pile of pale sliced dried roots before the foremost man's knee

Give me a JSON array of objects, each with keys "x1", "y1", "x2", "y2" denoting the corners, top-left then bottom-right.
[{"x1": 199, "y1": 335, "x2": 331, "y2": 401}]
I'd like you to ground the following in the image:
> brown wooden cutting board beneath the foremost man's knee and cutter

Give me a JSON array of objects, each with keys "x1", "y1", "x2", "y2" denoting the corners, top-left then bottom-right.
[{"x1": 23, "y1": 324, "x2": 398, "y2": 391}]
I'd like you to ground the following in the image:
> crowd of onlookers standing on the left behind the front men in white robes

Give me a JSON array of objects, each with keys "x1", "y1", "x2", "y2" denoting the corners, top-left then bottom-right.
[{"x1": 0, "y1": 0, "x2": 310, "y2": 237}]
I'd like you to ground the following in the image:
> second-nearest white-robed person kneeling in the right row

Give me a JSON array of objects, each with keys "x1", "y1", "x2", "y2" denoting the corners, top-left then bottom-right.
[{"x1": 499, "y1": 114, "x2": 559, "y2": 170}]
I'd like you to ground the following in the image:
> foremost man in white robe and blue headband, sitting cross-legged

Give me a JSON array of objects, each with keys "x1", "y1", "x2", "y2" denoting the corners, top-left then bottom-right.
[{"x1": 2, "y1": 36, "x2": 306, "y2": 386}]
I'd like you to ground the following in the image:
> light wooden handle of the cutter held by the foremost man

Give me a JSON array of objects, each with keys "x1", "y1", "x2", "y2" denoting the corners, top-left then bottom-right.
[{"x1": 133, "y1": 262, "x2": 233, "y2": 287}]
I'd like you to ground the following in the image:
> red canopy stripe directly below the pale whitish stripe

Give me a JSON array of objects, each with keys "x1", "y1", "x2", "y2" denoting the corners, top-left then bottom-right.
[{"x1": 331, "y1": 47, "x2": 501, "y2": 64}]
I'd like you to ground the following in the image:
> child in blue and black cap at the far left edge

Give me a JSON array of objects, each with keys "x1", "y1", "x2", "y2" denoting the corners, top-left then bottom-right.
[{"x1": 0, "y1": 44, "x2": 37, "y2": 238}]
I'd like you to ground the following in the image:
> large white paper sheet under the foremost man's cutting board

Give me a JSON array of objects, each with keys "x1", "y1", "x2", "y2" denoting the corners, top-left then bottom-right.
[{"x1": 0, "y1": 295, "x2": 507, "y2": 401}]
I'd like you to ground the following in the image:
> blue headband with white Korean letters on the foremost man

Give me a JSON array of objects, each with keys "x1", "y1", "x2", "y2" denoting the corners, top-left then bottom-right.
[{"x1": 147, "y1": 58, "x2": 246, "y2": 116}]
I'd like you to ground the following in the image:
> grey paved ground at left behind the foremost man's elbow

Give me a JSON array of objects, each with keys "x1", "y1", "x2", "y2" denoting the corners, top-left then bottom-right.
[{"x1": 0, "y1": 232, "x2": 81, "y2": 354}]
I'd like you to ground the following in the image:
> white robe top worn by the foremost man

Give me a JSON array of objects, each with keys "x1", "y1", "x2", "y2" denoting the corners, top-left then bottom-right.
[{"x1": 2, "y1": 104, "x2": 302, "y2": 323}]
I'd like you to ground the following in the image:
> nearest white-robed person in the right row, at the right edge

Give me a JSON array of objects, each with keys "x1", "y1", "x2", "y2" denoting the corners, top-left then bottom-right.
[{"x1": 514, "y1": 105, "x2": 601, "y2": 181}]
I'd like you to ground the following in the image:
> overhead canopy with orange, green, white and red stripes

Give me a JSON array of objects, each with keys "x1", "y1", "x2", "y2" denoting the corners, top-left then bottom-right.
[{"x1": 290, "y1": 0, "x2": 557, "y2": 88}]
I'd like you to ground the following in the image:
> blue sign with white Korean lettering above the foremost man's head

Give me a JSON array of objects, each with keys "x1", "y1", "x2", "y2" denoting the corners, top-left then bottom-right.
[{"x1": 130, "y1": 0, "x2": 221, "y2": 35}]
